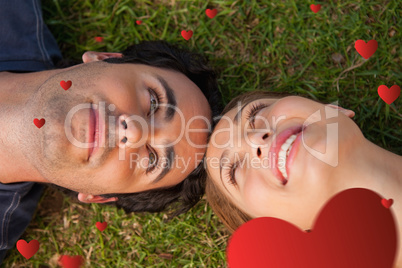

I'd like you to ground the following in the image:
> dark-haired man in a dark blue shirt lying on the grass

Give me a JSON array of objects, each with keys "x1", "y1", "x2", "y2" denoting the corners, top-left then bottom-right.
[{"x1": 0, "y1": 1, "x2": 219, "y2": 262}]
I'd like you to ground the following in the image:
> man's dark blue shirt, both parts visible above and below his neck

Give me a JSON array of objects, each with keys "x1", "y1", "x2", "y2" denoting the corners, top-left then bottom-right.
[{"x1": 0, "y1": 0, "x2": 61, "y2": 264}]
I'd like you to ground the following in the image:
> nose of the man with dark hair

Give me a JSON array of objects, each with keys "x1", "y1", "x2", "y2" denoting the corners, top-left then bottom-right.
[{"x1": 118, "y1": 114, "x2": 149, "y2": 148}]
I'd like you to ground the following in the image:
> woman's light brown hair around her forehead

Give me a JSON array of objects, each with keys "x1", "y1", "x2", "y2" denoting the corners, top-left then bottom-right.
[{"x1": 205, "y1": 91, "x2": 290, "y2": 233}]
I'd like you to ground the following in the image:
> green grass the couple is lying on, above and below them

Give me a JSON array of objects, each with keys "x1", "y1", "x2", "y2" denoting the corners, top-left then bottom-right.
[{"x1": 4, "y1": 0, "x2": 402, "y2": 267}]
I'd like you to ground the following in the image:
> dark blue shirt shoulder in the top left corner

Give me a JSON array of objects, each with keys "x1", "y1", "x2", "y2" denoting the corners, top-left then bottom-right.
[{"x1": 0, "y1": 0, "x2": 61, "y2": 71}]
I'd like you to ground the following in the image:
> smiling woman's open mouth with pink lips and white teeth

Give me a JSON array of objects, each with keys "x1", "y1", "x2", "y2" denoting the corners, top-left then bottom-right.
[{"x1": 269, "y1": 126, "x2": 303, "y2": 185}]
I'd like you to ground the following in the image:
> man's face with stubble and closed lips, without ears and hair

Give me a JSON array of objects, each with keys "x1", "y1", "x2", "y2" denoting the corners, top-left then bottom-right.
[{"x1": 23, "y1": 62, "x2": 211, "y2": 195}]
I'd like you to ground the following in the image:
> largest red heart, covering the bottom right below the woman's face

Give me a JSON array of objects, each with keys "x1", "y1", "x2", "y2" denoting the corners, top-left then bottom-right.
[{"x1": 227, "y1": 188, "x2": 397, "y2": 268}]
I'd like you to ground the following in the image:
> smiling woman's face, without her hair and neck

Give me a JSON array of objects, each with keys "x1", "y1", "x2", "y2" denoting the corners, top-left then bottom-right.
[{"x1": 206, "y1": 96, "x2": 364, "y2": 229}]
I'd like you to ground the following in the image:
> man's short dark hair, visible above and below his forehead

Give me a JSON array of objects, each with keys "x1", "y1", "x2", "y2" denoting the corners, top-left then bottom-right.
[{"x1": 56, "y1": 41, "x2": 222, "y2": 217}]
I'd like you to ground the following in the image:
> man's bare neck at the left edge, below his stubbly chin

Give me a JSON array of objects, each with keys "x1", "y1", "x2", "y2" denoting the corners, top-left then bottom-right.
[{"x1": 0, "y1": 71, "x2": 57, "y2": 183}]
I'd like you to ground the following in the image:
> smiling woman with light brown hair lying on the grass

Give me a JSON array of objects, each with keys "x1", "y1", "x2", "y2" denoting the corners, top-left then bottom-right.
[{"x1": 206, "y1": 92, "x2": 402, "y2": 263}]
